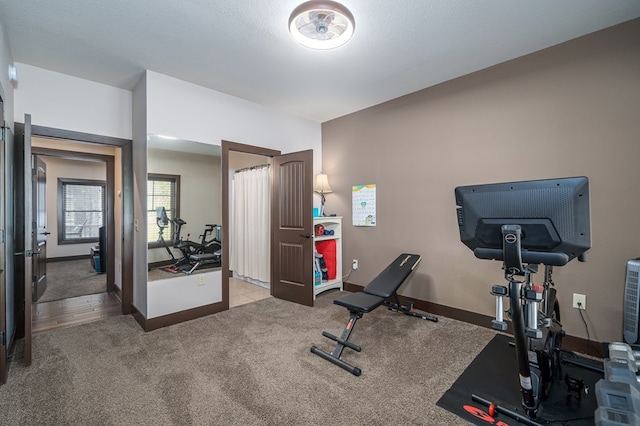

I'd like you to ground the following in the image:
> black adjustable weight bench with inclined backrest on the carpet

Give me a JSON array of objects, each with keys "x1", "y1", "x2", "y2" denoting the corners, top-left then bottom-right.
[{"x1": 311, "y1": 253, "x2": 438, "y2": 376}]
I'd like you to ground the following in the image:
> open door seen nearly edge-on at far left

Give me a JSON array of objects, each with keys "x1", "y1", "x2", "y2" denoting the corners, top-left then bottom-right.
[{"x1": 14, "y1": 114, "x2": 34, "y2": 365}]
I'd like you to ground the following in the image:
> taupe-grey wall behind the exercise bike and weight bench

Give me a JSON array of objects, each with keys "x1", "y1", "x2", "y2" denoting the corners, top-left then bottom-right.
[{"x1": 322, "y1": 20, "x2": 640, "y2": 341}]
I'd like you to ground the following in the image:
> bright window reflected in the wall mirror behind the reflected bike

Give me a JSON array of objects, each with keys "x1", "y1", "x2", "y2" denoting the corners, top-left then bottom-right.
[{"x1": 147, "y1": 173, "x2": 180, "y2": 247}]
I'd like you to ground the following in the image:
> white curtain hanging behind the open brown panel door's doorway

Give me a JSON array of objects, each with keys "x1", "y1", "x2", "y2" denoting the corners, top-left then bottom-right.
[{"x1": 229, "y1": 166, "x2": 271, "y2": 283}]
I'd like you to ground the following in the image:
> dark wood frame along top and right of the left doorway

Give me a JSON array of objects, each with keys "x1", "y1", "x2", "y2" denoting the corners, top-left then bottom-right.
[{"x1": 14, "y1": 123, "x2": 133, "y2": 315}]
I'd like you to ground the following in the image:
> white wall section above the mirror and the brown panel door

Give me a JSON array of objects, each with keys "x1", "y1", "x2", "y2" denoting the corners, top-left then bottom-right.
[{"x1": 147, "y1": 71, "x2": 322, "y2": 173}]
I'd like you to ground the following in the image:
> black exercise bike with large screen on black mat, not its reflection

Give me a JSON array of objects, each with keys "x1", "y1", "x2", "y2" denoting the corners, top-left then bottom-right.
[{"x1": 455, "y1": 176, "x2": 591, "y2": 425}]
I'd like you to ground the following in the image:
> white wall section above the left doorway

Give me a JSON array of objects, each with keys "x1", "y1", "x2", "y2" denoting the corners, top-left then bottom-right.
[{"x1": 14, "y1": 63, "x2": 132, "y2": 139}]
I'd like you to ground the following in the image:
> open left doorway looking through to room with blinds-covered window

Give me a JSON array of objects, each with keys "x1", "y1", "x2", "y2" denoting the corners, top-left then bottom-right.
[{"x1": 32, "y1": 146, "x2": 121, "y2": 333}]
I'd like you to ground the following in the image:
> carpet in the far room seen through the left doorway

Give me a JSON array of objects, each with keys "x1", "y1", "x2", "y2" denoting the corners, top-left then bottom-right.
[{"x1": 38, "y1": 259, "x2": 107, "y2": 303}]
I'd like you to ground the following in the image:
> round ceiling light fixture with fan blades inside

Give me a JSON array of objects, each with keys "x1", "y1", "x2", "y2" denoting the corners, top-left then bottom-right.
[{"x1": 289, "y1": 1, "x2": 355, "y2": 50}]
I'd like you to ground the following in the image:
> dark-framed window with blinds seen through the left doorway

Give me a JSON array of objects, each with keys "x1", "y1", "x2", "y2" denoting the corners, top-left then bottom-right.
[{"x1": 58, "y1": 178, "x2": 106, "y2": 244}]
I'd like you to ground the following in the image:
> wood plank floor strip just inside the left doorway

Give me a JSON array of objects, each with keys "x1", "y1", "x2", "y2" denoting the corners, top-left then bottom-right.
[{"x1": 32, "y1": 293, "x2": 122, "y2": 333}]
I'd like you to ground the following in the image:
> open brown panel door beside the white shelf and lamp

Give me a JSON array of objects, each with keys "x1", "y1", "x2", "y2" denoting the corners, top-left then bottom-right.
[{"x1": 271, "y1": 150, "x2": 313, "y2": 306}]
